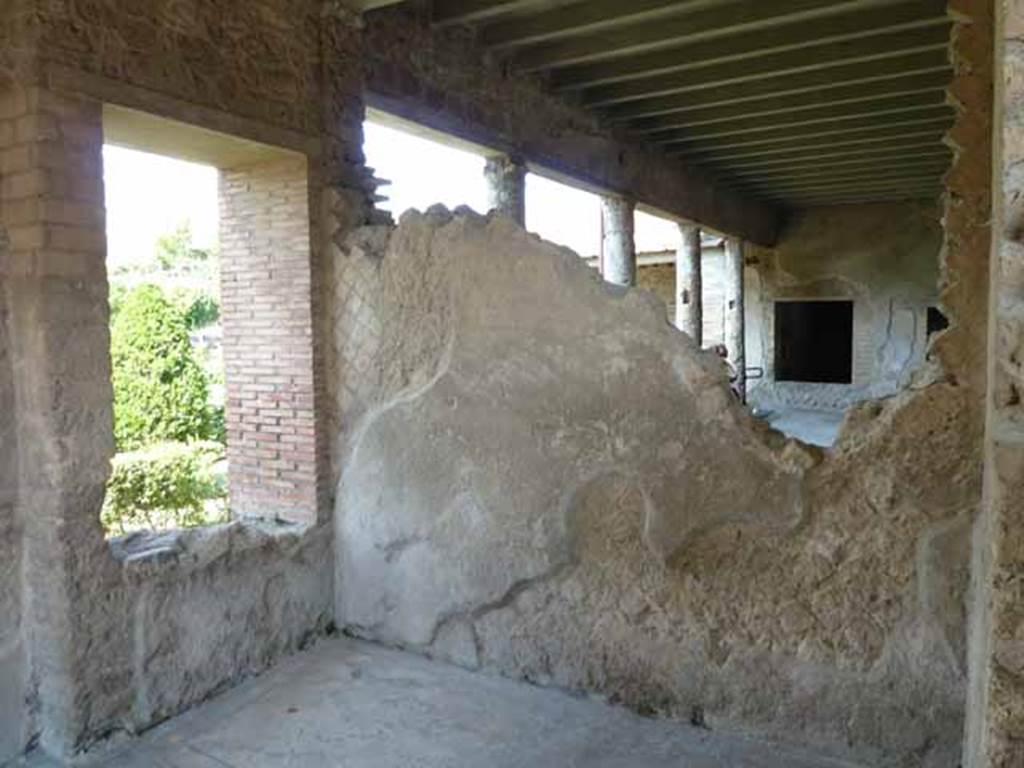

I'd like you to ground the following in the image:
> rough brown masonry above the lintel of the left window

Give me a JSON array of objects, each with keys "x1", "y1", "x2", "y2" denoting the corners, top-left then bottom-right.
[{"x1": 39, "y1": 0, "x2": 321, "y2": 135}]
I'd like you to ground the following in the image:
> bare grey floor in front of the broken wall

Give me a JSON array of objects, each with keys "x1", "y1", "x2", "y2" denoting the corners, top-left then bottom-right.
[{"x1": 19, "y1": 638, "x2": 851, "y2": 768}]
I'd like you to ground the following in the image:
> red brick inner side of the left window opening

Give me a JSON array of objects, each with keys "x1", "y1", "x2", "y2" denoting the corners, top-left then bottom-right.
[{"x1": 219, "y1": 157, "x2": 317, "y2": 522}]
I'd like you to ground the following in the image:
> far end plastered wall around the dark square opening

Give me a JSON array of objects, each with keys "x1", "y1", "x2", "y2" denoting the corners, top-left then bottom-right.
[{"x1": 746, "y1": 202, "x2": 943, "y2": 409}]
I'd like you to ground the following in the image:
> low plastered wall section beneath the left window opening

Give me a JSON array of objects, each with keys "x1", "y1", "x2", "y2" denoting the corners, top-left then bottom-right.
[{"x1": 113, "y1": 522, "x2": 332, "y2": 730}]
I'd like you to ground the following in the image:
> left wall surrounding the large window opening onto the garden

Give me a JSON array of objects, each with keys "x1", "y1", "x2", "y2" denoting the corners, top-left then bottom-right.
[{"x1": 0, "y1": 0, "x2": 372, "y2": 760}]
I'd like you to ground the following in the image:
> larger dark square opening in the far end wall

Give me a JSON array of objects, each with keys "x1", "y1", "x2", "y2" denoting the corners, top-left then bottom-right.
[{"x1": 775, "y1": 301, "x2": 853, "y2": 384}]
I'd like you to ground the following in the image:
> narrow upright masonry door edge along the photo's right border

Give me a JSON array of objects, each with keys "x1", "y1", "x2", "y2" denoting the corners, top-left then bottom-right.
[{"x1": 964, "y1": 0, "x2": 1024, "y2": 768}]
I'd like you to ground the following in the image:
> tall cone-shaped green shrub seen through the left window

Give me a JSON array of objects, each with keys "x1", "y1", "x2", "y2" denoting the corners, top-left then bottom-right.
[{"x1": 111, "y1": 285, "x2": 218, "y2": 451}]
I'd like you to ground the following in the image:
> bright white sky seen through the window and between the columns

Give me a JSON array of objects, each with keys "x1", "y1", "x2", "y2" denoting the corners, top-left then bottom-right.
[{"x1": 103, "y1": 122, "x2": 678, "y2": 267}]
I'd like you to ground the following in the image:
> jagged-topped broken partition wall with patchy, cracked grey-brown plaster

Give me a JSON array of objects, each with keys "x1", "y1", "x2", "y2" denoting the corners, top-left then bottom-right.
[{"x1": 336, "y1": 212, "x2": 981, "y2": 766}]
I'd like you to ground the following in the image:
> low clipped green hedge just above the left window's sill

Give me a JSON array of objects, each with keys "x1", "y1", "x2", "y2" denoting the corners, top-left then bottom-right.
[{"x1": 101, "y1": 442, "x2": 226, "y2": 536}]
